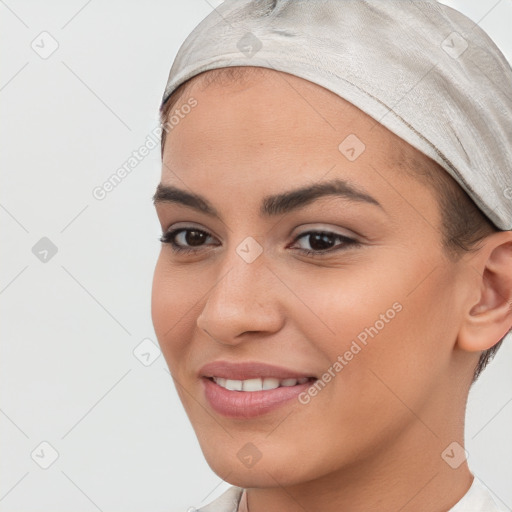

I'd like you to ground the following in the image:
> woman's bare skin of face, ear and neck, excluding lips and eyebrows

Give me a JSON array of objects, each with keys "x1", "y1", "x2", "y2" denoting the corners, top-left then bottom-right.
[{"x1": 152, "y1": 71, "x2": 512, "y2": 512}]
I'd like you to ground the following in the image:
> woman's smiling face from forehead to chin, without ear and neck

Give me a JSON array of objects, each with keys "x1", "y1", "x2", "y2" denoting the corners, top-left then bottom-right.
[{"x1": 152, "y1": 72, "x2": 476, "y2": 486}]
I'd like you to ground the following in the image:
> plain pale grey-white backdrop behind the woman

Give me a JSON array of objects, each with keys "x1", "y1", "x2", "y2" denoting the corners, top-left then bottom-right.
[{"x1": 0, "y1": 0, "x2": 512, "y2": 512}]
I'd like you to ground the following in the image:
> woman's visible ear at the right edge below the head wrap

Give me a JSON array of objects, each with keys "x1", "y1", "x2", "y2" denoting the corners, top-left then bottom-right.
[{"x1": 458, "y1": 231, "x2": 512, "y2": 352}]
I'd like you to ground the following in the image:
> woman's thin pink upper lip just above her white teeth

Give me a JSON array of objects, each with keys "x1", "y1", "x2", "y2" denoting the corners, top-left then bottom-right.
[{"x1": 199, "y1": 361, "x2": 314, "y2": 380}]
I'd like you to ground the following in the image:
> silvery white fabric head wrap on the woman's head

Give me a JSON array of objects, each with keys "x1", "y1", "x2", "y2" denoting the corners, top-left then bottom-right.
[{"x1": 162, "y1": 0, "x2": 512, "y2": 230}]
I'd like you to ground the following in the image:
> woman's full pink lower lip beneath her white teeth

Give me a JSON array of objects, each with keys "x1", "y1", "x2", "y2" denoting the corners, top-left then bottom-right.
[{"x1": 202, "y1": 377, "x2": 313, "y2": 418}]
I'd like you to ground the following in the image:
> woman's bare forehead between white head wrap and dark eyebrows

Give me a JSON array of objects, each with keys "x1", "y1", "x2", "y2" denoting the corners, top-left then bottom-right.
[{"x1": 161, "y1": 72, "x2": 439, "y2": 244}]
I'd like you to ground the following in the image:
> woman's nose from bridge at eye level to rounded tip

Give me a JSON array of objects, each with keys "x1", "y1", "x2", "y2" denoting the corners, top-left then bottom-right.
[{"x1": 197, "y1": 237, "x2": 278, "y2": 343}]
